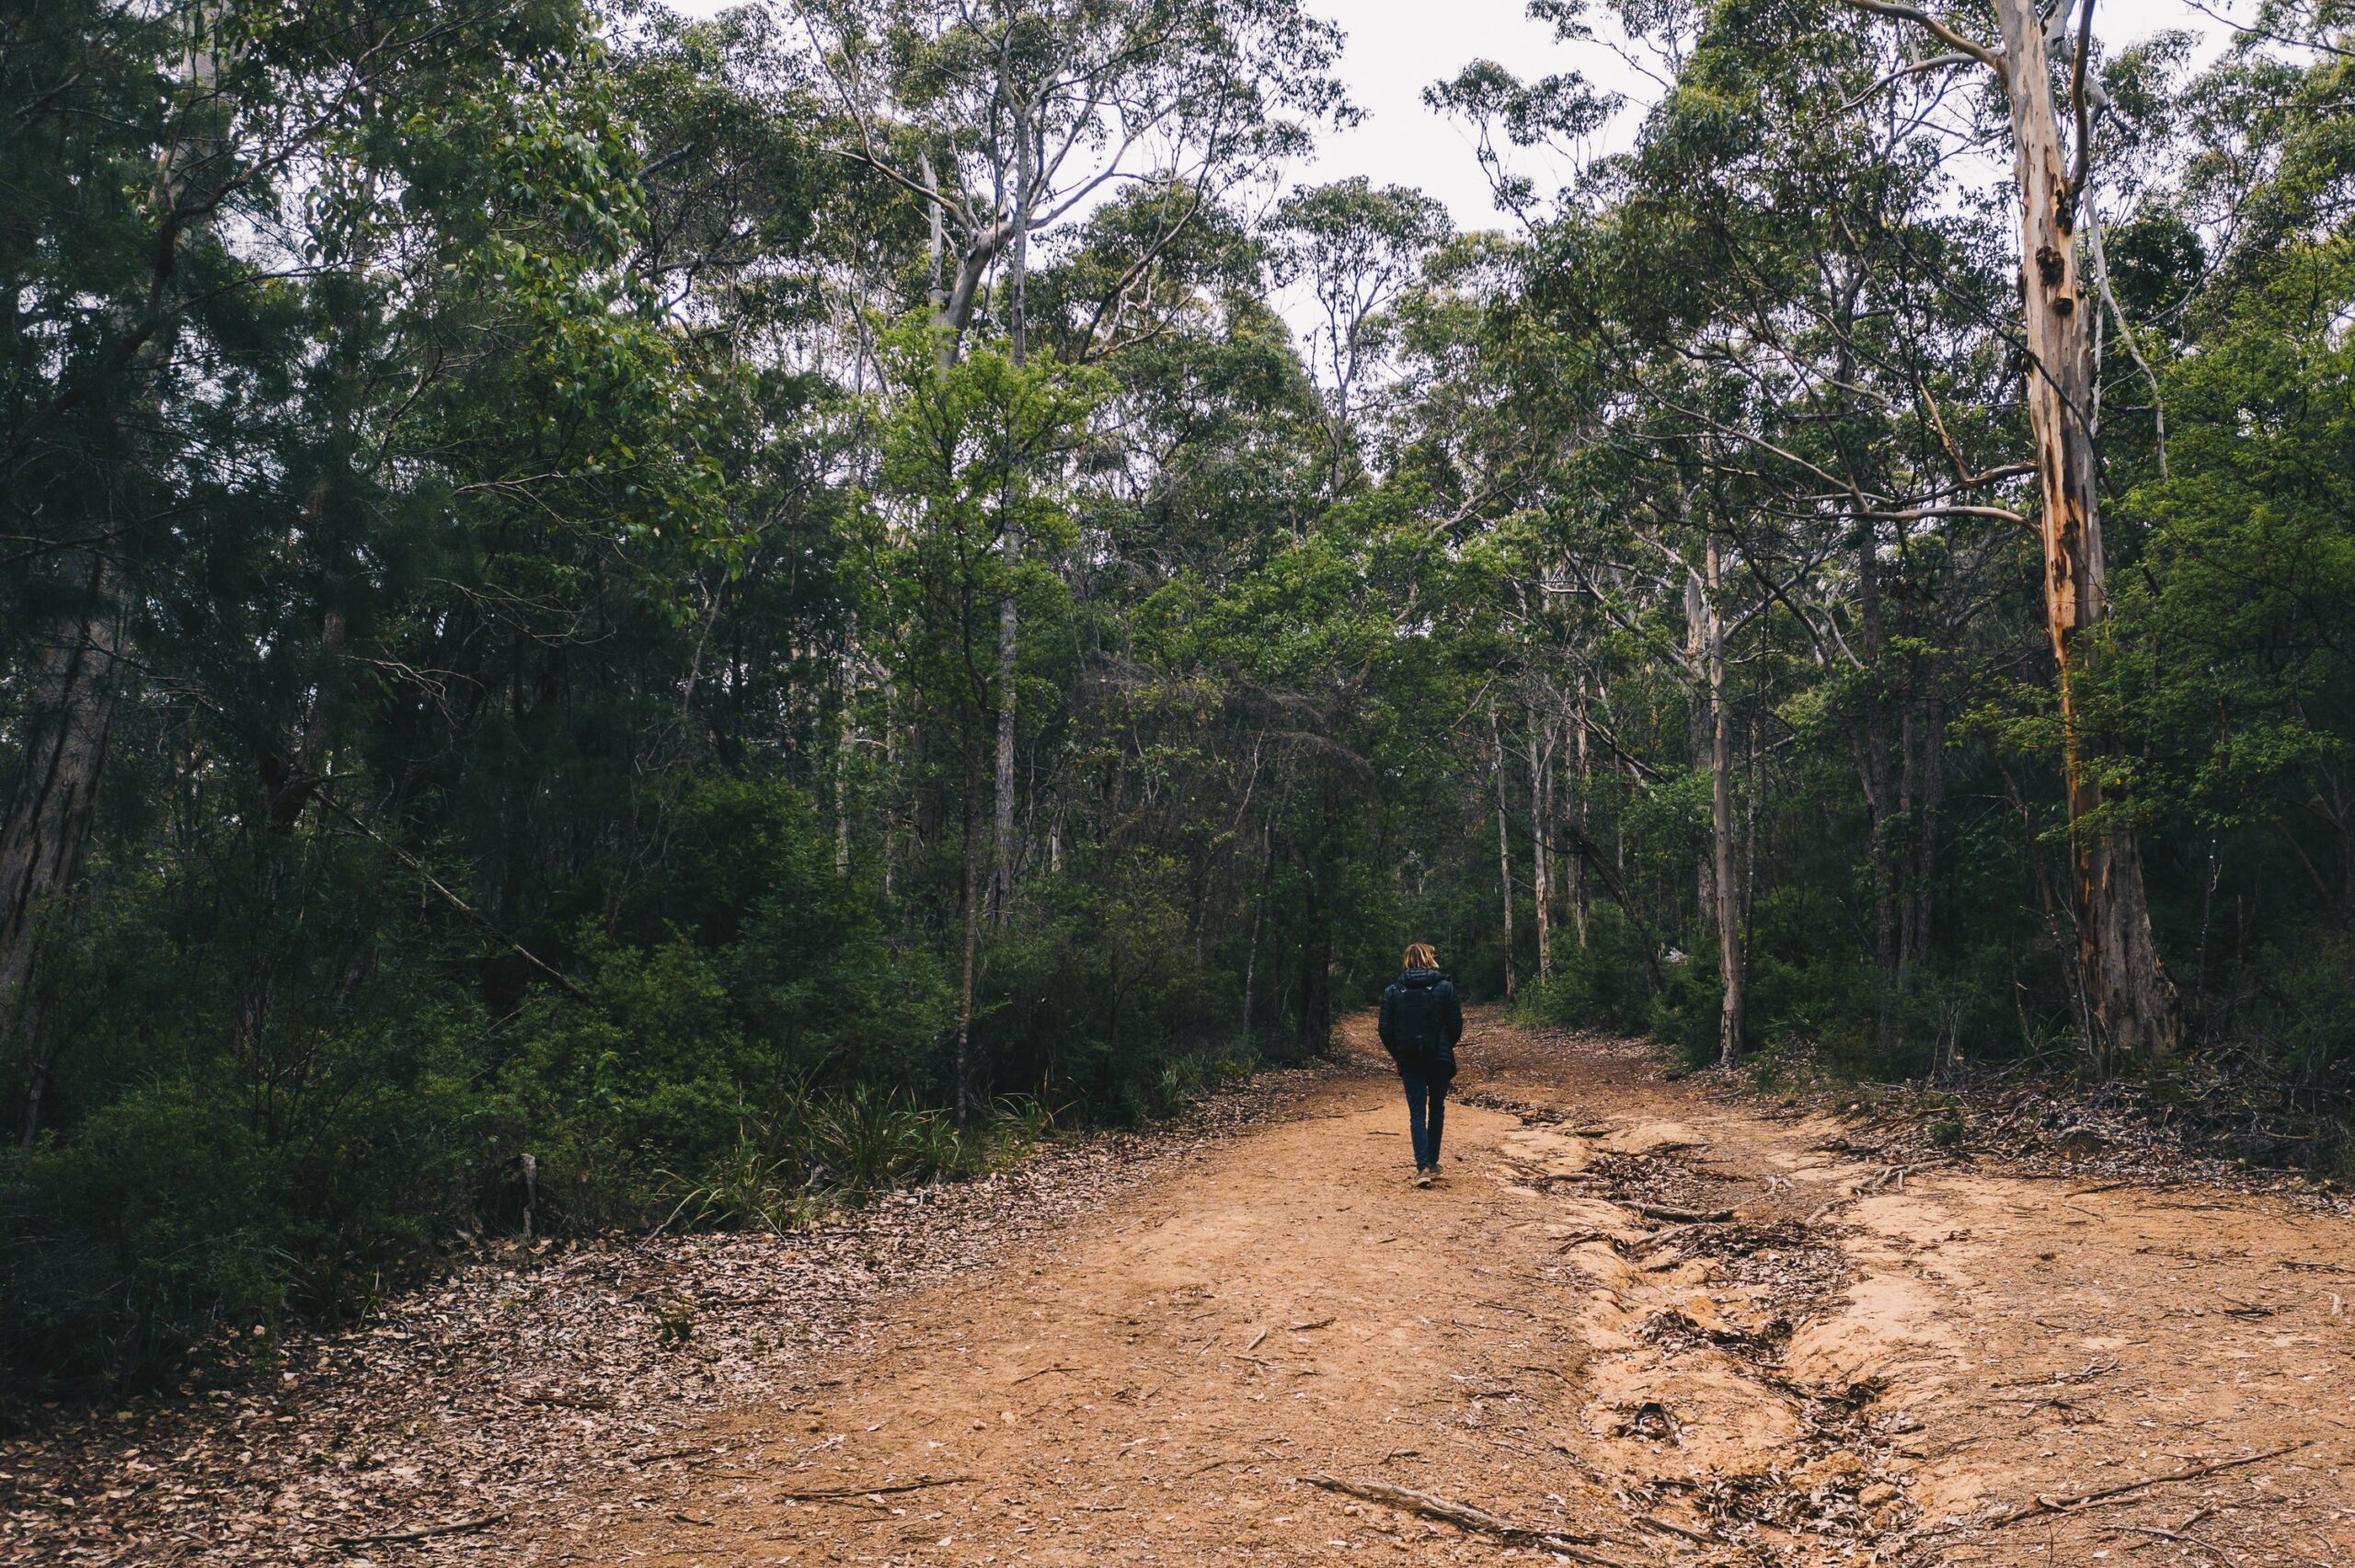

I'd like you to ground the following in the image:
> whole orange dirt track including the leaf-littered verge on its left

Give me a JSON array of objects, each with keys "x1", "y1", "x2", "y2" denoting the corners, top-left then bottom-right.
[{"x1": 14, "y1": 1017, "x2": 2355, "y2": 1568}]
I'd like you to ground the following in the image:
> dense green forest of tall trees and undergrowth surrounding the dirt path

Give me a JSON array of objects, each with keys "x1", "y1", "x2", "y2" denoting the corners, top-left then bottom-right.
[{"x1": 0, "y1": 0, "x2": 2355, "y2": 1378}]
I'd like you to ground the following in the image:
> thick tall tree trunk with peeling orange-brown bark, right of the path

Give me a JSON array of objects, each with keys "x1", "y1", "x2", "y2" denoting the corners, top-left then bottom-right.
[{"x1": 1994, "y1": 0, "x2": 2183, "y2": 1055}]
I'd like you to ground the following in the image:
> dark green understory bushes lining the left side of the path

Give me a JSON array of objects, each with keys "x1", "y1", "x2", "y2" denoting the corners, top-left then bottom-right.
[{"x1": 0, "y1": 777, "x2": 1258, "y2": 1396}]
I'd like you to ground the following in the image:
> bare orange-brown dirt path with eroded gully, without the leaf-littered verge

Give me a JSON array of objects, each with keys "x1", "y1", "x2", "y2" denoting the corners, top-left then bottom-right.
[{"x1": 546, "y1": 1020, "x2": 2355, "y2": 1568}]
